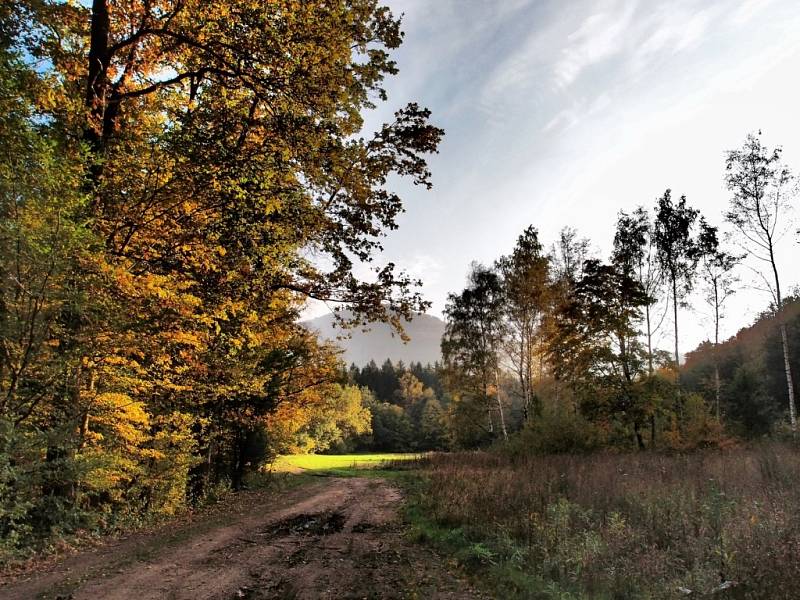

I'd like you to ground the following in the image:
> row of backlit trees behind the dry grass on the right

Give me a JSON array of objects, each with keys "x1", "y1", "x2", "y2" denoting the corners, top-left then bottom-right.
[{"x1": 442, "y1": 133, "x2": 800, "y2": 451}]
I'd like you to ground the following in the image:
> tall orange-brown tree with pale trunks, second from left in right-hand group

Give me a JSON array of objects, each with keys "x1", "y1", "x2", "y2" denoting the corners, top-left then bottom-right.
[{"x1": 497, "y1": 226, "x2": 549, "y2": 420}]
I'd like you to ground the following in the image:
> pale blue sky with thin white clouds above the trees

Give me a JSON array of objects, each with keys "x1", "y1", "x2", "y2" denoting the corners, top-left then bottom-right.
[{"x1": 310, "y1": 0, "x2": 800, "y2": 350}]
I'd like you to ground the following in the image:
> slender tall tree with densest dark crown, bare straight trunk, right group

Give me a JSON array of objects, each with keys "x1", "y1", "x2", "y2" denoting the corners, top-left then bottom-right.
[{"x1": 653, "y1": 190, "x2": 699, "y2": 389}]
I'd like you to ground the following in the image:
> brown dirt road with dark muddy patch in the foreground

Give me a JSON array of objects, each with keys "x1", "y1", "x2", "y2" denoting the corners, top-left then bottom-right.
[{"x1": 0, "y1": 478, "x2": 479, "y2": 600}]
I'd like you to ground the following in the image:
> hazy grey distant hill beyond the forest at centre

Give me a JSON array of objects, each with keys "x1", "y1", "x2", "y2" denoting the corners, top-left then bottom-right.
[{"x1": 304, "y1": 314, "x2": 444, "y2": 366}]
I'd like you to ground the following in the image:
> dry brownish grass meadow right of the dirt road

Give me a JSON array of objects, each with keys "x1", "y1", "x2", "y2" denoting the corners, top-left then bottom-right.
[{"x1": 410, "y1": 445, "x2": 800, "y2": 598}]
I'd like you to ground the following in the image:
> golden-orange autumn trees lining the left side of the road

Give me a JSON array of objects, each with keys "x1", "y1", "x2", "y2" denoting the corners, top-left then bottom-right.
[{"x1": 0, "y1": 0, "x2": 443, "y2": 554}]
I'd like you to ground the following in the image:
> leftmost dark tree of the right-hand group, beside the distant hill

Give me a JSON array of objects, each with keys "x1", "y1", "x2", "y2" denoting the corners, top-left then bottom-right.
[{"x1": 442, "y1": 265, "x2": 508, "y2": 438}]
